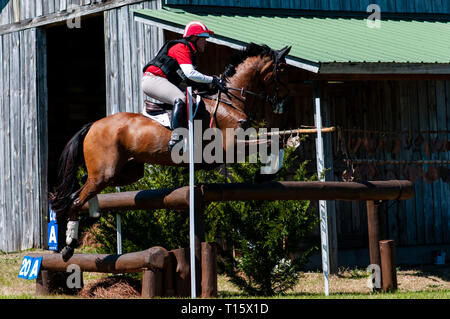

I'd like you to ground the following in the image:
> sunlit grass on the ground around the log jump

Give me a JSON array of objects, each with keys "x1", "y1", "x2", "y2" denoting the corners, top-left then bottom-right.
[{"x1": 0, "y1": 250, "x2": 450, "y2": 299}]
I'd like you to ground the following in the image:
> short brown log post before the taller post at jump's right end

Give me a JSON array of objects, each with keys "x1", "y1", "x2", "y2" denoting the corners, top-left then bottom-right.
[{"x1": 379, "y1": 240, "x2": 397, "y2": 292}]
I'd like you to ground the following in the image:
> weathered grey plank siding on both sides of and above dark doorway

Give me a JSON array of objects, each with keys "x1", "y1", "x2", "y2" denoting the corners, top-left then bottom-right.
[{"x1": 0, "y1": 0, "x2": 163, "y2": 252}]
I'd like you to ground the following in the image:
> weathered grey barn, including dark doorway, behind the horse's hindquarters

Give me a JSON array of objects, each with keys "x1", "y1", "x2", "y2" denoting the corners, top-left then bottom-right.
[{"x1": 0, "y1": 0, "x2": 163, "y2": 252}]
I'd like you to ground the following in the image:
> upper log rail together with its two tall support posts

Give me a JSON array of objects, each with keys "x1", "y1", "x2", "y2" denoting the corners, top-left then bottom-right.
[{"x1": 76, "y1": 180, "x2": 414, "y2": 296}]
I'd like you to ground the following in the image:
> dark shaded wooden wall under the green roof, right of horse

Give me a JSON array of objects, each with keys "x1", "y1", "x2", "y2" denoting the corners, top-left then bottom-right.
[{"x1": 286, "y1": 78, "x2": 450, "y2": 249}]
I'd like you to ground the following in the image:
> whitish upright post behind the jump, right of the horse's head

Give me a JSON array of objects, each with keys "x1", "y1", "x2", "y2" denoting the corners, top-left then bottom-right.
[{"x1": 313, "y1": 83, "x2": 330, "y2": 296}]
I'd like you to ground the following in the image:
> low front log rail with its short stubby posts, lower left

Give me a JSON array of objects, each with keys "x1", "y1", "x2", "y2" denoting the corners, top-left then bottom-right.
[{"x1": 29, "y1": 243, "x2": 217, "y2": 298}]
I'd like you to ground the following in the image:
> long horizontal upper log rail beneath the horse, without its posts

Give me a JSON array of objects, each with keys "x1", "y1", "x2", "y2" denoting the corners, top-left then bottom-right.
[{"x1": 82, "y1": 180, "x2": 414, "y2": 214}]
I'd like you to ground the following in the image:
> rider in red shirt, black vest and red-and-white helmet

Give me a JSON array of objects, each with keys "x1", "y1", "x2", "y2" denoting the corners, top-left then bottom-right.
[{"x1": 142, "y1": 21, "x2": 225, "y2": 151}]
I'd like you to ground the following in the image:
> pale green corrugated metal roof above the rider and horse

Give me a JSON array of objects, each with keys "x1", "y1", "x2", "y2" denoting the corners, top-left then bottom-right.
[{"x1": 135, "y1": 7, "x2": 450, "y2": 72}]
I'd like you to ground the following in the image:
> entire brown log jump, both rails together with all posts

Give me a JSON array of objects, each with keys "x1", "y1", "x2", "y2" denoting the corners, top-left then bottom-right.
[{"x1": 48, "y1": 180, "x2": 414, "y2": 297}]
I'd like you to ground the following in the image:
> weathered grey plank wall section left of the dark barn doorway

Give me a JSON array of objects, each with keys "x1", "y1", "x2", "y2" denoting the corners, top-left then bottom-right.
[{"x1": 0, "y1": 30, "x2": 43, "y2": 252}]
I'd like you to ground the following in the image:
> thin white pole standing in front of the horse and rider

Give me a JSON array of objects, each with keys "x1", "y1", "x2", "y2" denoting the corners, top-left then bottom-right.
[{"x1": 186, "y1": 87, "x2": 197, "y2": 298}]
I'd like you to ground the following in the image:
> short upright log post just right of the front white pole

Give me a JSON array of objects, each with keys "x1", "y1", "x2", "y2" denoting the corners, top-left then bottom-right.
[{"x1": 201, "y1": 242, "x2": 217, "y2": 298}]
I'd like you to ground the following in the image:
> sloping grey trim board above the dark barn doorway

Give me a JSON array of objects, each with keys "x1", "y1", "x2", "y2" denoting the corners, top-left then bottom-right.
[{"x1": 0, "y1": 0, "x2": 145, "y2": 35}]
